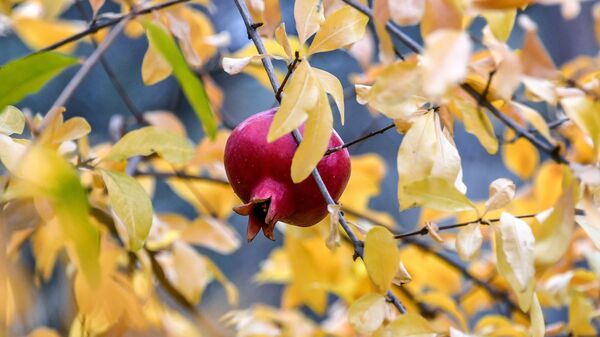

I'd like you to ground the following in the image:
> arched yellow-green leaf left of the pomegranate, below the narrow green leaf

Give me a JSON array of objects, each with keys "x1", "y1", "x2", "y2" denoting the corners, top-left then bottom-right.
[{"x1": 103, "y1": 126, "x2": 194, "y2": 165}]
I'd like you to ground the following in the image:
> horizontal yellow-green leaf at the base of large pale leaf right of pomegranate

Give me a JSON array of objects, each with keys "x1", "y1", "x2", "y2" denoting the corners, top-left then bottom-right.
[{"x1": 404, "y1": 178, "x2": 477, "y2": 212}]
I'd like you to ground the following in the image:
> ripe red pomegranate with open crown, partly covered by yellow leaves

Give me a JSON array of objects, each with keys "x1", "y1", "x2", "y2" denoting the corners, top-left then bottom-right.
[{"x1": 225, "y1": 108, "x2": 350, "y2": 241}]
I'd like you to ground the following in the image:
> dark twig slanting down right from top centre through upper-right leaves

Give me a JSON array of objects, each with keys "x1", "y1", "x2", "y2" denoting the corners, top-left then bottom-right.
[{"x1": 343, "y1": 0, "x2": 569, "y2": 164}]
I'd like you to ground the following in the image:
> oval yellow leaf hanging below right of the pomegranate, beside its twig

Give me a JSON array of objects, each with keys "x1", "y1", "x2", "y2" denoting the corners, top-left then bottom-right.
[{"x1": 364, "y1": 227, "x2": 400, "y2": 293}]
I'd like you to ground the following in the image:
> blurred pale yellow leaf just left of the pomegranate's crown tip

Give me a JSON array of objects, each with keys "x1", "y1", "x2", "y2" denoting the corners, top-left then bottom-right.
[{"x1": 181, "y1": 217, "x2": 241, "y2": 254}]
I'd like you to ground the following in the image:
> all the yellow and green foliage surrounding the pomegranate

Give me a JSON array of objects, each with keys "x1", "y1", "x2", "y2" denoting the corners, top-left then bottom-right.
[{"x1": 0, "y1": 0, "x2": 600, "y2": 337}]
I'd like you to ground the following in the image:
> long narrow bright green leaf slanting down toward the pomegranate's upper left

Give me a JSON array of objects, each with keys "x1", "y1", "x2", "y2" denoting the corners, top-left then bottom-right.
[{"x1": 145, "y1": 22, "x2": 217, "y2": 139}]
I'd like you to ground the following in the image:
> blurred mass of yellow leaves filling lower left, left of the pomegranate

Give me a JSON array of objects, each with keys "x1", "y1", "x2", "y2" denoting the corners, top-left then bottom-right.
[{"x1": 0, "y1": 106, "x2": 240, "y2": 336}]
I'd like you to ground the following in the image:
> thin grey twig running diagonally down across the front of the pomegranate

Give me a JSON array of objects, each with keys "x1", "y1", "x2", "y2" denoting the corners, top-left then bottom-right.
[{"x1": 234, "y1": 0, "x2": 406, "y2": 313}]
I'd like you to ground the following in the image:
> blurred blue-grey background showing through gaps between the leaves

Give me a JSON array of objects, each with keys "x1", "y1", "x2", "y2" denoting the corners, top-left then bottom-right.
[{"x1": 0, "y1": 0, "x2": 599, "y2": 329}]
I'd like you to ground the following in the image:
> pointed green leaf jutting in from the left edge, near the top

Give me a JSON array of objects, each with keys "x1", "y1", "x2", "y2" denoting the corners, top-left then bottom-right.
[{"x1": 0, "y1": 52, "x2": 78, "y2": 110}]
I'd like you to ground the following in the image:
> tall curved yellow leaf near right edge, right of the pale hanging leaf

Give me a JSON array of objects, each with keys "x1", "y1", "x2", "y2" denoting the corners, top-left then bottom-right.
[{"x1": 535, "y1": 166, "x2": 579, "y2": 265}]
